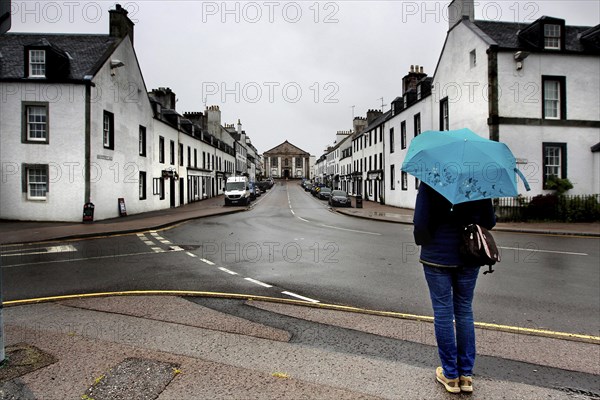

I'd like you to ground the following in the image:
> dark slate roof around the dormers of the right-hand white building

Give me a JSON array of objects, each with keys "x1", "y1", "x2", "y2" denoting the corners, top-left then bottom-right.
[{"x1": 473, "y1": 20, "x2": 594, "y2": 52}]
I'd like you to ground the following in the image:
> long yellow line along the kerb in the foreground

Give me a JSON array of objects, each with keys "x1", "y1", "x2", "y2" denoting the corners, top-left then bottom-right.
[{"x1": 2, "y1": 290, "x2": 600, "y2": 344}]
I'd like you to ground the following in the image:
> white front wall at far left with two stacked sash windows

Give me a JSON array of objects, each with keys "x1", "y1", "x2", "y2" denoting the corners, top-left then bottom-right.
[{"x1": 0, "y1": 82, "x2": 85, "y2": 221}]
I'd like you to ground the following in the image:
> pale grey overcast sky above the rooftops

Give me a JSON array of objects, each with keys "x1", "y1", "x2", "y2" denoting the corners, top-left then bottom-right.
[{"x1": 11, "y1": 0, "x2": 600, "y2": 157}]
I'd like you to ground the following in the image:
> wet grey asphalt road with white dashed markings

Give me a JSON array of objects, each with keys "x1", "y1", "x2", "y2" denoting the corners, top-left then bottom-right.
[{"x1": 2, "y1": 183, "x2": 600, "y2": 335}]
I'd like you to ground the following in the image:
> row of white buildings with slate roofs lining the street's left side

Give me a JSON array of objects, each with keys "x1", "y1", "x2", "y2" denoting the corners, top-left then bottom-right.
[{"x1": 0, "y1": 5, "x2": 258, "y2": 221}]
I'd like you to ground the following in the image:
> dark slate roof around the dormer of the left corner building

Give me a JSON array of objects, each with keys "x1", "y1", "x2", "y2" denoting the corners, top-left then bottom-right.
[{"x1": 0, "y1": 33, "x2": 122, "y2": 80}]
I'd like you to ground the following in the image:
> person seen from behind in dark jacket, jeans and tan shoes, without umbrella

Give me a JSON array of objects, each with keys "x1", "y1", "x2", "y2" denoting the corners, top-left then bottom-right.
[{"x1": 413, "y1": 182, "x2": 496, "y2": 393}]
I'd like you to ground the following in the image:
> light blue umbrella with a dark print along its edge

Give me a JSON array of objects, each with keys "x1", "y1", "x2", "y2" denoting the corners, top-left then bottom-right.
[{"x1": 402, "y1": 128, "x2": 529, "y2": 204}]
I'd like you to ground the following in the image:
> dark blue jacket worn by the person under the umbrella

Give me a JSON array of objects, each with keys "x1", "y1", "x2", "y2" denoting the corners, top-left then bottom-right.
[{"x1": 413, "y1": 183, "x2": 496, "y2": 267}]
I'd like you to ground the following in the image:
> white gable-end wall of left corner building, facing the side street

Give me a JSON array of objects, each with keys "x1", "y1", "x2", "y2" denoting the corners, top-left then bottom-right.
[{"x1": 90, "y1": 39, "x2": 156, "y2": 220}]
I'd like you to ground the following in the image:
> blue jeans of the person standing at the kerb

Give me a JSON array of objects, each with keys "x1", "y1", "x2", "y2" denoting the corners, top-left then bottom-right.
[{"x1": 423, "y1": 265, "x2": 479, "y2": 379}]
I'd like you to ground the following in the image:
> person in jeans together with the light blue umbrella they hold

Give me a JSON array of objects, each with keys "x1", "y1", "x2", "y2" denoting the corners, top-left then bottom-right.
[{"x1": 402, "y1": 129, "x2": 527, "y2": 393}]
